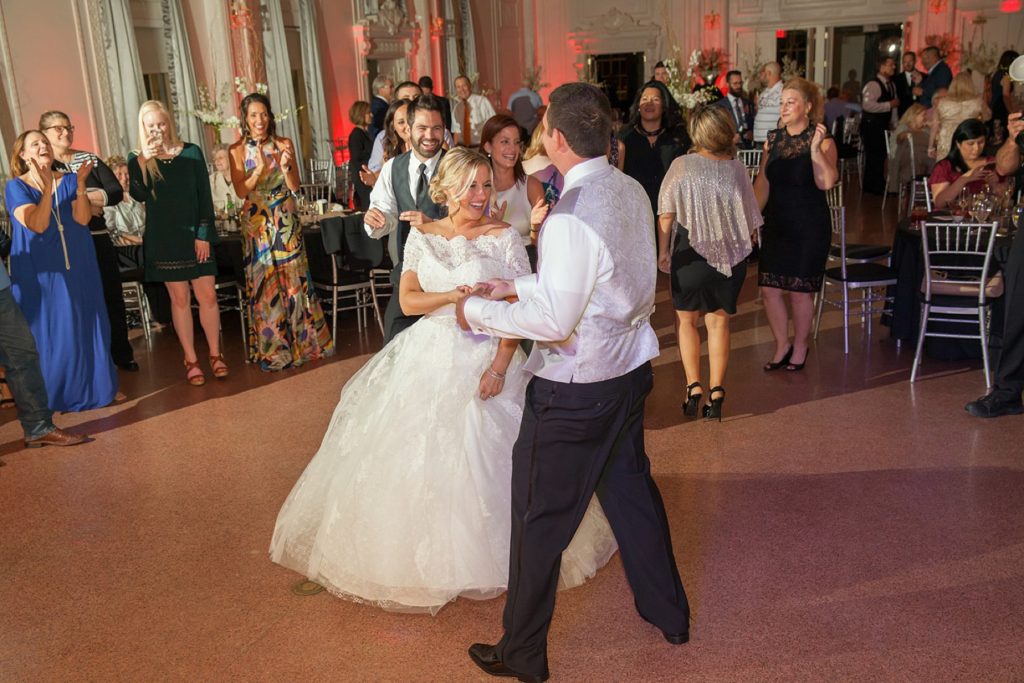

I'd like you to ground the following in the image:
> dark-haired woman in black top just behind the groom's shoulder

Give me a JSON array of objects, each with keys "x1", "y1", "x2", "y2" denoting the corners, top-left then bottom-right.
[{"x1": 617, "y1": 81, "x2": 690, "y2": 215}]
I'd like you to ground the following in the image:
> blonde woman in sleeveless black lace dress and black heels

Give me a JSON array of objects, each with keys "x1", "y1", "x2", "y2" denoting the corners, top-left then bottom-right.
[{"x1": 754, "y1": 78, "x2": 839, "y2": 371}]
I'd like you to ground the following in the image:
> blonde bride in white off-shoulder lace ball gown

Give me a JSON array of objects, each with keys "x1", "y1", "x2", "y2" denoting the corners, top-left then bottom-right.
[{"x1": 270, "y1": 147, "x2": 616, "y2": 613}]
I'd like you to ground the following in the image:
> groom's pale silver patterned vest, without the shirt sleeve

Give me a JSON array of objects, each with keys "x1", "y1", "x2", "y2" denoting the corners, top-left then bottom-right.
[{"x1": 539, "y1": 166, "x2": 658, "y2": 383}]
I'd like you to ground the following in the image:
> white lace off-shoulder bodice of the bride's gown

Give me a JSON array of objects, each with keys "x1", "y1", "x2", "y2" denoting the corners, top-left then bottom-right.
[{"x1": 402, "y1": 228, "x2": 529, "y2": 301}]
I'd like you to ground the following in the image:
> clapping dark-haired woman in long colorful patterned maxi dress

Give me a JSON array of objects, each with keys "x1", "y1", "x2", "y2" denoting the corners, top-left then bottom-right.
[{"x1": 231, "y1": 93, "x2": 334, "y2": 371}]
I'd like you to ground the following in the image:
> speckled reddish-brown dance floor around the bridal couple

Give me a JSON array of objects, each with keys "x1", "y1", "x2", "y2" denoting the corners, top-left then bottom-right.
[{"x1": 0, "y1": 193, "x2": 1024, "y2": 682}]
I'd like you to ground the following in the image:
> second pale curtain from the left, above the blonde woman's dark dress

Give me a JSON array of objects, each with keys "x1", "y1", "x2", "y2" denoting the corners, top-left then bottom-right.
[{"x1": 160, "y1": 0, "x2": 203, "y2": 149}]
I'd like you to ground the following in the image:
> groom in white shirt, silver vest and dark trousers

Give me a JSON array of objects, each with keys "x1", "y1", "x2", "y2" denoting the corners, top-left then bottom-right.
[{"x1": 457, "y1": 83, "x2": 689, "y2": 681}]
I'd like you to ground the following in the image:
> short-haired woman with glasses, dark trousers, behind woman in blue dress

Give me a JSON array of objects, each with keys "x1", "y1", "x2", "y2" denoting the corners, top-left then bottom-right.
[{"x1": 39, "y1": 111, "x2": 138, "y2": 372}]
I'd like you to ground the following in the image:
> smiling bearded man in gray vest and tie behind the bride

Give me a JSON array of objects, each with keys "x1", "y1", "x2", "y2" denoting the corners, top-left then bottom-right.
[{"x1": 362, "y1": 95, "x2": 445, "y2": 344}]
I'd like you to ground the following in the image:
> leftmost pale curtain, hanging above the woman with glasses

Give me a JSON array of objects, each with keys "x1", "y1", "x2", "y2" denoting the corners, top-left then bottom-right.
[{"x1": 99, "y1": 0, "x2": 145, "y2": 154}]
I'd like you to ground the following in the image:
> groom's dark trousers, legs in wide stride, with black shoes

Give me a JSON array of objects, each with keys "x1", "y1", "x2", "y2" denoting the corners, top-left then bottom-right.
[{"x1": 498, "y1": 362, "x2": 689, "y2": 676}]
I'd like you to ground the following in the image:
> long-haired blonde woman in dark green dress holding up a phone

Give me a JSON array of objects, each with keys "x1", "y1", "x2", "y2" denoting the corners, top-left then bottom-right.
[{"x1": 128, "y1": 99, "x2": 228, "y2": 386}]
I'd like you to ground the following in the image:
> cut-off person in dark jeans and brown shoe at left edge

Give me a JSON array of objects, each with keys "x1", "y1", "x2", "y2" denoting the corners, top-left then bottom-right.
[{"x1": 0, "y1": 231, "x2": 88, "y2": 449}]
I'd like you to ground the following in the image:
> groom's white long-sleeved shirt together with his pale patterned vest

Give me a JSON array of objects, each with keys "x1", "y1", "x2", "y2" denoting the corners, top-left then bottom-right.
[{"x1": 465, "y1": 157, "x2": 658, "y2": 383}]
